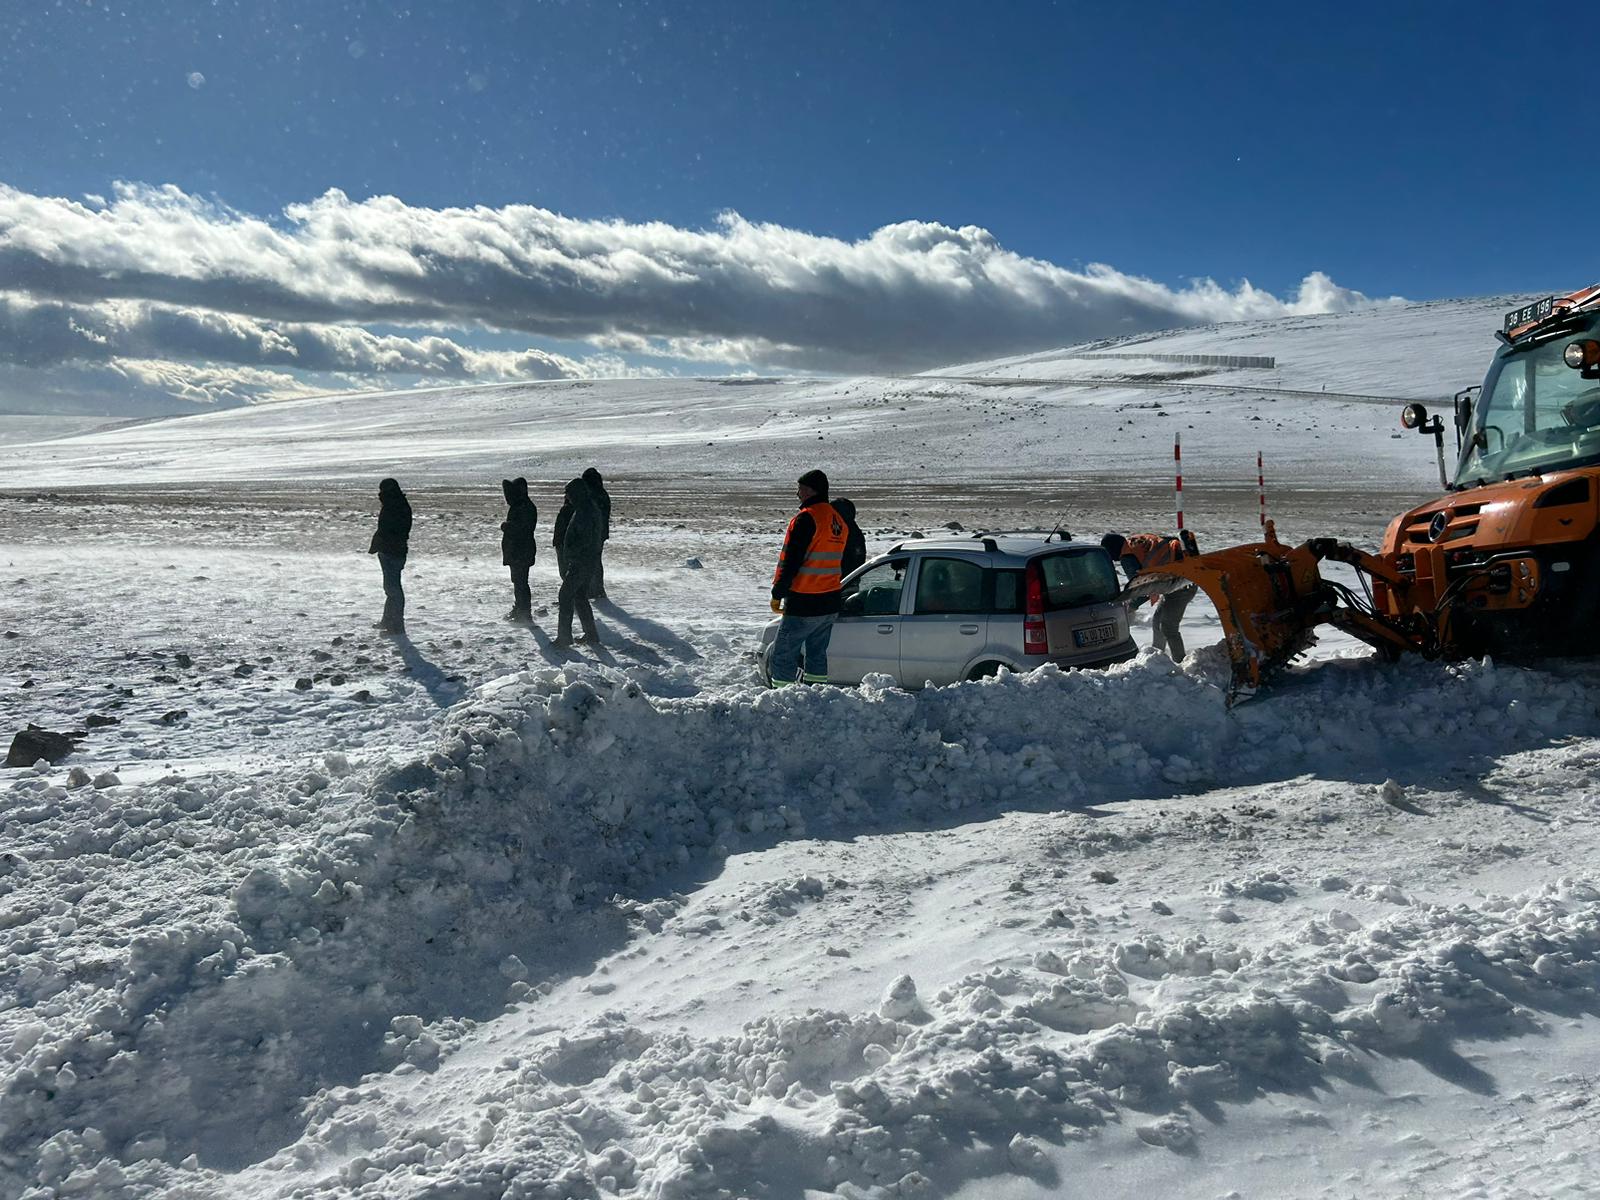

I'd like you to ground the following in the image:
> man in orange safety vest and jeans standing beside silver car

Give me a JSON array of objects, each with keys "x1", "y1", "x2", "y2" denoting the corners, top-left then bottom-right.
[{"x1": 771, "y1": 470, "x2": 850, "y2": 688}]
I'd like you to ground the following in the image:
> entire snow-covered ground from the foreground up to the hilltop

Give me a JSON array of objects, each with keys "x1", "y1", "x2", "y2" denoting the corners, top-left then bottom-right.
[{"x1": 0, "y1": 301, "x2": 1600, "y2": 1200}]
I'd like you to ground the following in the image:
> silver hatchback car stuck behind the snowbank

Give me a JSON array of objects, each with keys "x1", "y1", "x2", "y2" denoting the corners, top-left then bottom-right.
[{"x1": 757, "y1": 531, "x2": 1138, "y2": 688}]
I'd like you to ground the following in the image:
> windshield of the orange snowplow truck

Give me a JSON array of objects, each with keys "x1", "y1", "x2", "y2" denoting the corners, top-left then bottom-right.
[{"x1": 1456, "y1": 320, "x2": 1600, "y2": 488}]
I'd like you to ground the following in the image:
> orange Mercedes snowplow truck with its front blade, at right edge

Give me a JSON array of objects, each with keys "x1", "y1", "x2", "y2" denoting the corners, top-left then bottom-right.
[{"x1": 1126, "y1": 285, "x2": 1600, "y2": 702}]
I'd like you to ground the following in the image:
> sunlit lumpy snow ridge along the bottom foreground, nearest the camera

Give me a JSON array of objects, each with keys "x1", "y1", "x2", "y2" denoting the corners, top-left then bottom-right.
[{"x1": 262, "y1": 882, "x2": 1600, "y2": 1200}]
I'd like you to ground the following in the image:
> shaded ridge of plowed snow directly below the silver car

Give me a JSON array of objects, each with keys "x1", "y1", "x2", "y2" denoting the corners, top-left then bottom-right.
[{"x1": 0, "y1": 656, "x2": 1600, "y2": 1194}]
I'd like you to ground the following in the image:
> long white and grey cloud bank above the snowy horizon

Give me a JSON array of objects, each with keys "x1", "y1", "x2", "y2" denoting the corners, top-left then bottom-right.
[{"x1": 0, "y1": 184, "x2": 1374, "y2": 403}]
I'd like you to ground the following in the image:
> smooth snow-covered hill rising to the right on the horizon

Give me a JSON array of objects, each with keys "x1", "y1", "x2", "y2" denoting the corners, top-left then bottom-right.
[{"x1": 0, "y1": 299, "x2": 1510, "y2": 490}]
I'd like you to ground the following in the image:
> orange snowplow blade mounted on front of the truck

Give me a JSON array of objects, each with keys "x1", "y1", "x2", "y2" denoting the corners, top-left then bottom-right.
[{"x1": 1123, "y1": 534, "x2": 1330, "y2": 704}]
